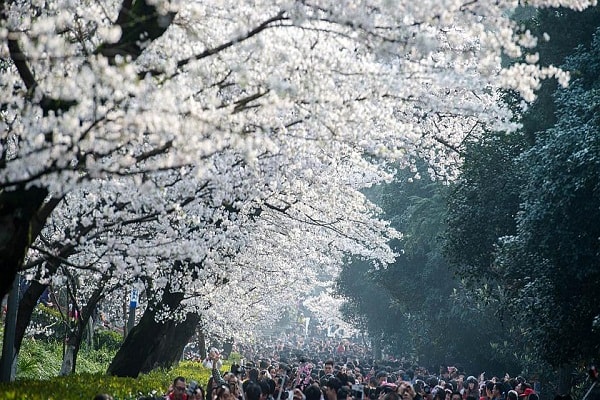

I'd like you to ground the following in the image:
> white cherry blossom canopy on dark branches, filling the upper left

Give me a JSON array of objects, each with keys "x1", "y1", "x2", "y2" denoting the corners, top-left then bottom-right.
[{"x1": 0, "y1": 0, "x2": 594, "y2": 376}]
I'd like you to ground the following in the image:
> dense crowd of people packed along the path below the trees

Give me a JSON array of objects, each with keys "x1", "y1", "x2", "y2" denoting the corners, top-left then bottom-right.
[{"x1": 158, "y1": 349, "x2": 539, "y2": 400}]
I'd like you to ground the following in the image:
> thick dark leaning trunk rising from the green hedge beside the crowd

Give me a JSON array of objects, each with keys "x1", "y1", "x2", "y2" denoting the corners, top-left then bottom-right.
[{"x1": 107, "y1": 293, "x2": 200, "y2": 378}]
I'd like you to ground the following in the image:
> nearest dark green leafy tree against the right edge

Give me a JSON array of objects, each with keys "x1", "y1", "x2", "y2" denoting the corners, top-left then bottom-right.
[{"x1": 498, "y1": 26, "x2": 600, "y2": 366}]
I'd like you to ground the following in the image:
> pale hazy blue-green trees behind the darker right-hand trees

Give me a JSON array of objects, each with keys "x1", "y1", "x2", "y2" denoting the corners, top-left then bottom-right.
[{"x1": 337, "y1": 165, "x2": 520, "y2": 374}]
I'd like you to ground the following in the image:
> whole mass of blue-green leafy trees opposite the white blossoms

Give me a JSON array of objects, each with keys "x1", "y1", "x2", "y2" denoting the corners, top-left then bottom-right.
[{"x1": 337, "y1": 7, "x2": 600, "y2": 391}]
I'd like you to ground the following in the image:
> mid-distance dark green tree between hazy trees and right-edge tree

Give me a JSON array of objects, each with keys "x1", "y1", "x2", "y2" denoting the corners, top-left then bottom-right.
[{"x1": 444, "y1": 132, "x2": 527, "y2": 286}]
